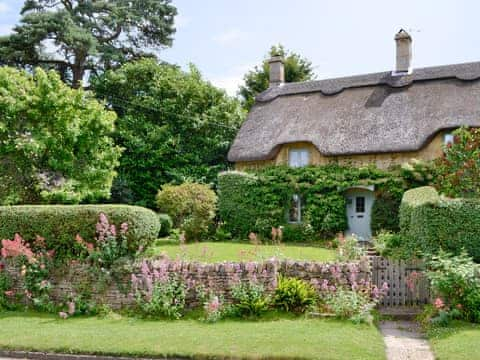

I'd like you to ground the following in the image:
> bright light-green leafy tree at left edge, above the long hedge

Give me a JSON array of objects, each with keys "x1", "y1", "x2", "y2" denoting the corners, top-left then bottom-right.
[{"x1": 0, "y1": 67, "x2": 121, "y2": 204}]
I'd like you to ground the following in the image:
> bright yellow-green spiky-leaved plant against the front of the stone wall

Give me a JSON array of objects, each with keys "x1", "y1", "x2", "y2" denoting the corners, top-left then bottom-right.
[{"x1": 273, "y1": 276, "x2": 316, "y2": 313}]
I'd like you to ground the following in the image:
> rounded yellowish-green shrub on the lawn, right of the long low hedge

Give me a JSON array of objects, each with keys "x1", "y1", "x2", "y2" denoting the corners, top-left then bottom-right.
[{"x1": 157, "y1": 183, "x2": 217, "y2": 240}]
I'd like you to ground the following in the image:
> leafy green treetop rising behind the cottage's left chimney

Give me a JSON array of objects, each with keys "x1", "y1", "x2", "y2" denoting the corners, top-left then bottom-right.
[{"x1": 239, "y1": 45, "x2": 315, "y2": 110}]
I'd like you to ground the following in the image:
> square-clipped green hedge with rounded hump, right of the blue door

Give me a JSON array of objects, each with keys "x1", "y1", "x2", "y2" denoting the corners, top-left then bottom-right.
[{"x1": 400, "y1": 187, "x2": 480, "y2": 262}]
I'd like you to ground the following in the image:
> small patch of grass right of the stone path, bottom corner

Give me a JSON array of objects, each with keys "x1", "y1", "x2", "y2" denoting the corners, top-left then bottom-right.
[{"x1": 428, "y1": 321, "x2": 480, "y2": 360}]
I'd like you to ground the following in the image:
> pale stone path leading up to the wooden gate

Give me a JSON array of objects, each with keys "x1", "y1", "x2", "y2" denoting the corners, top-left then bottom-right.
[{"x1": 380, "y1": 321, "x2": 435, "y2": 360}]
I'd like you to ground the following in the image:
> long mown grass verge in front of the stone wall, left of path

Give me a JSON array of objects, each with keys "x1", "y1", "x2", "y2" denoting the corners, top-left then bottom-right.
[{"x1": 0, "y1": 313, "x2": 385, "y2": 360}]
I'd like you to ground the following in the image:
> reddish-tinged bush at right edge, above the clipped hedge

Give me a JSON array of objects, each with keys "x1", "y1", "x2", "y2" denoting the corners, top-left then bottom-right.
[{"x1": 435, "y1": 128, "x2": 480, "y2": 198}]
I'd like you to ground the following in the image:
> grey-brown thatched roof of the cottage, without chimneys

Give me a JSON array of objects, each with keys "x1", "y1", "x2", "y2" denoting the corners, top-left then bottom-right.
[{"x1": 228, "y1": 62, "x2": 480, "y2": 162}]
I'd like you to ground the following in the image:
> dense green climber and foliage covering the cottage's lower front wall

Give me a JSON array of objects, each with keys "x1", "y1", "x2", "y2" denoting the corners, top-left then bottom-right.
[{"x1": 218, "y1": 164, "x2": 408, "y2": 241}]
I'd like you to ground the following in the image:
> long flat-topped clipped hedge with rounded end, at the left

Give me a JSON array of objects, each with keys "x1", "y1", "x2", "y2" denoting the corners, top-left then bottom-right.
[{"x1": 0, "y1": 205, "x2": 160, "y2": 258}]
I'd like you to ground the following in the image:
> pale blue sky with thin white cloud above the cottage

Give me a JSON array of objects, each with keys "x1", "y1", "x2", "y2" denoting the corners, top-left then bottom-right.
[{"x1": 0, "y1": 0, "x2": 480, "y2": 95}]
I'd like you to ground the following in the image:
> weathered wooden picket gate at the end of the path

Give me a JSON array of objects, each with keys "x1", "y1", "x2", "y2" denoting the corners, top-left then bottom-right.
[{"x1": 371, "y1": 256, "x2": 430, "y2": 307}]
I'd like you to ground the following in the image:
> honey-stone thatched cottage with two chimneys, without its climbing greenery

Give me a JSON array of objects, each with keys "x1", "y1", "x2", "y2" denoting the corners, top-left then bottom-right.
[{"x1": 228, "y1": 30, "x2": 480, "y2": 239}]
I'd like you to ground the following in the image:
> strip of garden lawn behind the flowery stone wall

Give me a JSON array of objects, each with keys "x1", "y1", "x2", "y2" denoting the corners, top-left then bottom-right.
[{"x1": 144, "y1": 240, "x2": 335, "y2": 263}]
